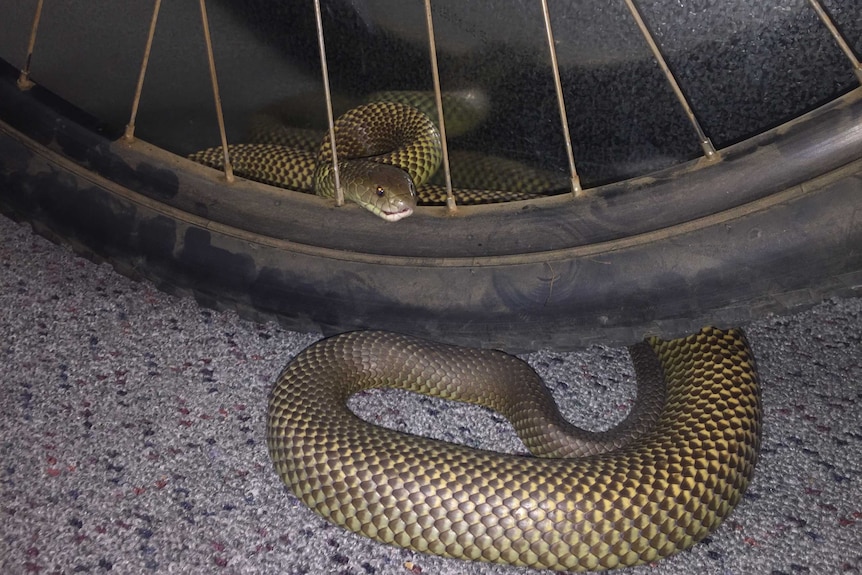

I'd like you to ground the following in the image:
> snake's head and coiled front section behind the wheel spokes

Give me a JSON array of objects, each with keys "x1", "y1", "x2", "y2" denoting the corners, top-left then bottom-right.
[{"x1": 189, "y1": 97, "x2": 565, "y2": 221}]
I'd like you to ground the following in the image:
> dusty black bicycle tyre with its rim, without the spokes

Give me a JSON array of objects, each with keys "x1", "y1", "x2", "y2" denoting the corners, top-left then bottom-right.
[{"x1": 0, "y1": 65, "x2": 862, "y2": 351}]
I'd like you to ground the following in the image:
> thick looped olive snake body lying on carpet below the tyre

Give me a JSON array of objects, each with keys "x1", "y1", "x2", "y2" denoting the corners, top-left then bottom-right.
[{"x1": 266, "y1": 327, "x2": 762, "y2": 571}]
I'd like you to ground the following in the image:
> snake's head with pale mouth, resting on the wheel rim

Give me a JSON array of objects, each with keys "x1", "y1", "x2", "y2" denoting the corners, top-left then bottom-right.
[{"x1": 342, "y1": 161, "x2": 416, "y2": 222}]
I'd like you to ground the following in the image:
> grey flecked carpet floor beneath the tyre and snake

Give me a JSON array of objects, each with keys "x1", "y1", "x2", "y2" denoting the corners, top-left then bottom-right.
[{"x1": 0, "y1": 217, "x2": 862, "y2": 575}]
